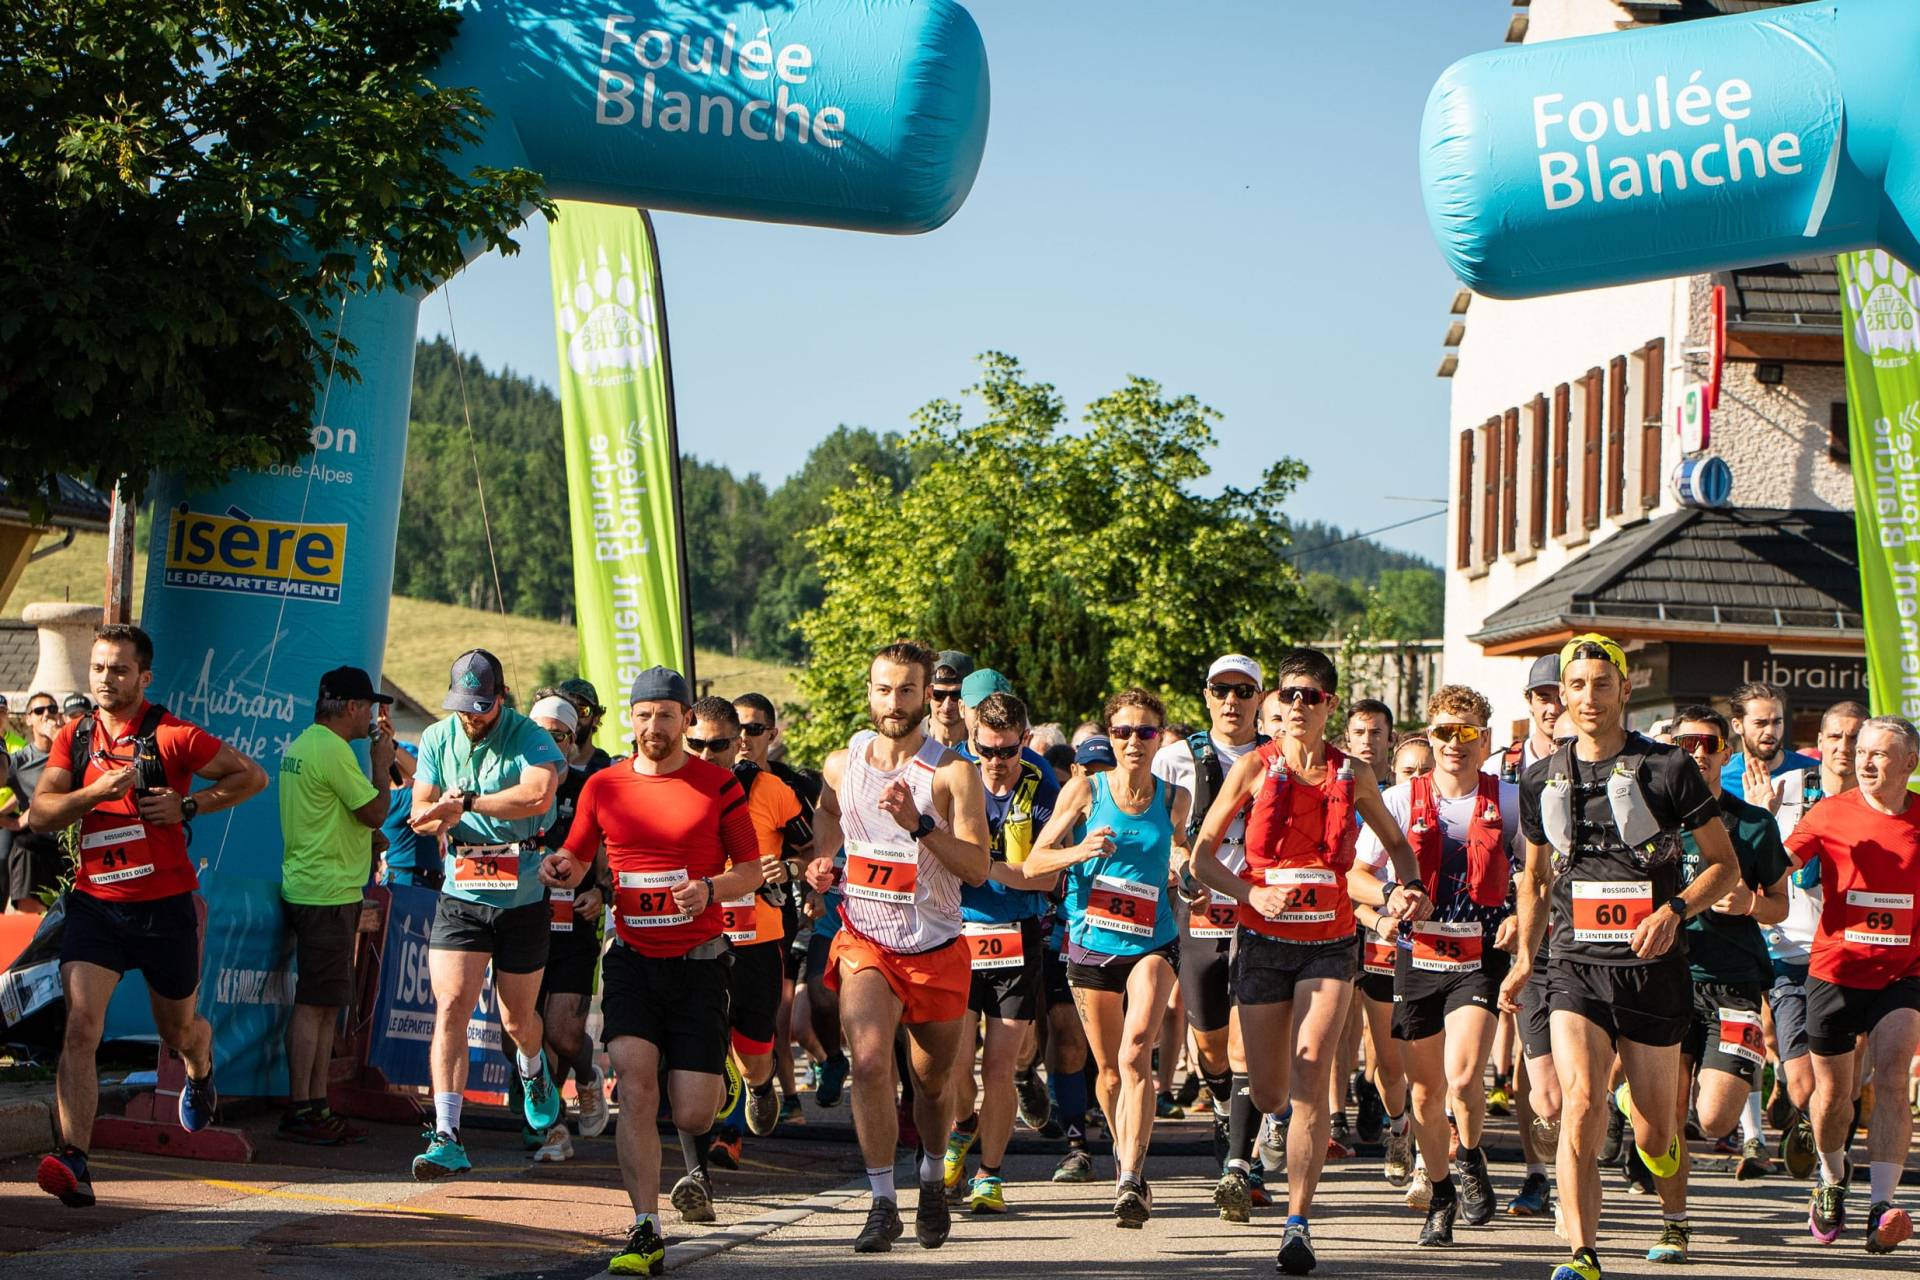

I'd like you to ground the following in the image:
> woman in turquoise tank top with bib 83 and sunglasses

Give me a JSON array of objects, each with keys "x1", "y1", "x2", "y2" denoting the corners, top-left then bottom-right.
[{"x1": 1027, "y1": 689, "x2": 1192, "y2": 1228}]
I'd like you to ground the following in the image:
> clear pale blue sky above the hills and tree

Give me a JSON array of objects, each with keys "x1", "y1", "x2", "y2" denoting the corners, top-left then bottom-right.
[{"x1": 420, "y1": 0, "x2": 1511, "y2": 560}]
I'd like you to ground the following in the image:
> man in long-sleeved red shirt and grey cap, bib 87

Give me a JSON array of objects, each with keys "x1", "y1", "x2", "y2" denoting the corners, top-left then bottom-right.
[{"x1": 540, "y1": 666, "x2": 762, "y2": 1276}]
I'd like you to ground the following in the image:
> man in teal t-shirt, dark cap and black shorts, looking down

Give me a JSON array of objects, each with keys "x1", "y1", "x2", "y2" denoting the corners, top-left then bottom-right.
[{"x1": 401, "y1": 649, "x2": 566, "y2": 1182}]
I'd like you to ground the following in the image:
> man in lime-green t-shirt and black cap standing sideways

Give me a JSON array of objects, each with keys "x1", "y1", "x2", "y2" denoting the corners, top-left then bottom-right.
[{"x1": 280, "y1": 666, "x2": 394, "y2": 1146}]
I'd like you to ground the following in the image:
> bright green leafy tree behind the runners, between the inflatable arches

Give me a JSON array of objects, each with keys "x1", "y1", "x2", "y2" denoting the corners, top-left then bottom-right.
[{"x1": 795, "y1": 353, "x2": 1317, "y2": 756}]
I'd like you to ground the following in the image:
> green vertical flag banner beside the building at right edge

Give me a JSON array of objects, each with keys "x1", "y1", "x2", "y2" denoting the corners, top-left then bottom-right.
[{"x1": 1837, "y1": 249, "x2": 1920, "y2": 720}]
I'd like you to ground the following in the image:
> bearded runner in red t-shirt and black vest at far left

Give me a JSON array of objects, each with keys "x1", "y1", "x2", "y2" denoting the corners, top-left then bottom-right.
[{"x1": 27, "y1": 624, "x2": 267, "y2": 1209}]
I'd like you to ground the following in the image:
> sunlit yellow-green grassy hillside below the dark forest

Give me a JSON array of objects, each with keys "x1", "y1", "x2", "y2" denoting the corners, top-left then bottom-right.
[{"x1": 0, "y1": 533, "x2": 799, "y2": 706}]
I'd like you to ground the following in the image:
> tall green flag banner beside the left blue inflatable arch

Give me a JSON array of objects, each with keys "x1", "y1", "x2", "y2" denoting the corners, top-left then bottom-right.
[{"x1": 547, "y1": 200, "x2": 693, "y2": 754}]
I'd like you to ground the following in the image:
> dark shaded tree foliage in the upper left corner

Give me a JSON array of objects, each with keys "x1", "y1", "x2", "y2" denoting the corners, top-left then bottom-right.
[{"x1": 0, "y1": 0, "x2": 547, "y2": 510}]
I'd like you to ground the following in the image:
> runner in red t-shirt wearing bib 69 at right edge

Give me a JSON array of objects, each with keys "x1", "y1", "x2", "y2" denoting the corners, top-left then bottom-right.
[{"x1": 1788, "y1": 716, "x2": 1920, "y2": 1253}]
